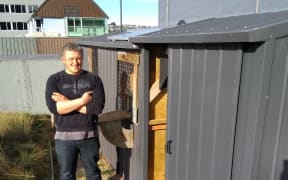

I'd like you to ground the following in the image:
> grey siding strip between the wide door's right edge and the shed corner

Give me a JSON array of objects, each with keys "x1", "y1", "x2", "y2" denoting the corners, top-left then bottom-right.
[{"x1": 232, "y1": 40, "x2": 274, "y2": 180}]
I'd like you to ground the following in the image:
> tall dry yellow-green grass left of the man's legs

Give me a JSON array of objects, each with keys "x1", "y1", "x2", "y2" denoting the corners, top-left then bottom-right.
[{"x1": 0, "y1": 112, "x2": 53, "y2": 179}]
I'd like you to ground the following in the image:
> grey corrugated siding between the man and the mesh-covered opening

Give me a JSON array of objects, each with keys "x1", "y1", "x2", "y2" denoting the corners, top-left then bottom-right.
[{"x1": 98, "y1": 48, "x2": 117, "y2": 168}]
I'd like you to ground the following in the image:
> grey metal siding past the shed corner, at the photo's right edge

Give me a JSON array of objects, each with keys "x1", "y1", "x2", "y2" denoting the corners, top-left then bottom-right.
[{"x1": 258, "y1": 37, "x2": 288, "y2": 180}]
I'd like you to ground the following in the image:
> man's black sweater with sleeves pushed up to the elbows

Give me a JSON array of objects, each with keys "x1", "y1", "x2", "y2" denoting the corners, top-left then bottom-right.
[{"x1": 45, "y1": 70, "x2": 105, "y2": 132}]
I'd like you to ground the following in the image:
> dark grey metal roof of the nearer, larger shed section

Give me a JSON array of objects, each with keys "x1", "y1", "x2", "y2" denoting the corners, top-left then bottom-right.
[{"x1": 129, "y1": 11, "x2": 288, "y2": 43}]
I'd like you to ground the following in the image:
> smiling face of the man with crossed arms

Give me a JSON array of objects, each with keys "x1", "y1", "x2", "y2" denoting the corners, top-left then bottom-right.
[{"x1": 61, "y1": 51, "x2": 83, "y2": 75}]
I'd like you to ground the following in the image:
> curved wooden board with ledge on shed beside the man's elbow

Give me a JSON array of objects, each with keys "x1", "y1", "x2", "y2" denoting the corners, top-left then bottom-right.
[{"x1": 98, "y1": 110, "x2": 134, "y2": 148}]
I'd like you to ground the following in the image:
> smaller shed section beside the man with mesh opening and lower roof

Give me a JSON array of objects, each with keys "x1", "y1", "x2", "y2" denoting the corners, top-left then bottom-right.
[{"x1": 77, "y1": 30, "x2": 165, "y2": 180}]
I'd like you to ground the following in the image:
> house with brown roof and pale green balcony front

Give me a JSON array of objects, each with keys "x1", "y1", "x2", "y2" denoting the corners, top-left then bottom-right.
[{"x1": 28, "y1": 0, "x2": 108, "y2": 37}]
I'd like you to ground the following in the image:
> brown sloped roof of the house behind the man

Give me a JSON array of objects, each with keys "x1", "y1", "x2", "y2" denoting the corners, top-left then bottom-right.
[{"x1": 32, "y1": 0, "x2": 109, "y2": 18}]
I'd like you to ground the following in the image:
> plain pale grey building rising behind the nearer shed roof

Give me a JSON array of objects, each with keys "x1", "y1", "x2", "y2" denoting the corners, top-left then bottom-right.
[{"x1": 158, "y1": 0, "x2": 288, "y2": 28}]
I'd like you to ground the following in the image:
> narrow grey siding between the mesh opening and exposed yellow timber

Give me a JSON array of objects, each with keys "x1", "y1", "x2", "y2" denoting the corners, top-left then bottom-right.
[{"x1": 130, "y1": 49, "x2": 149, "y2": 180}]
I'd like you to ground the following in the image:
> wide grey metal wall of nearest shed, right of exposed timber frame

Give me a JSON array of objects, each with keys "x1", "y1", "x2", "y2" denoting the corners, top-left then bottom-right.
[{"x1": 166, "y1": 39, "x2": 288, "y2": 180}]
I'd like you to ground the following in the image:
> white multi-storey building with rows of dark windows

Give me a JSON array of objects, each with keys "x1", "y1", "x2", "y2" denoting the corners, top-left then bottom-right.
[{"x1": 0, "y1": 0, "x2": 44, "y2": 37}]
